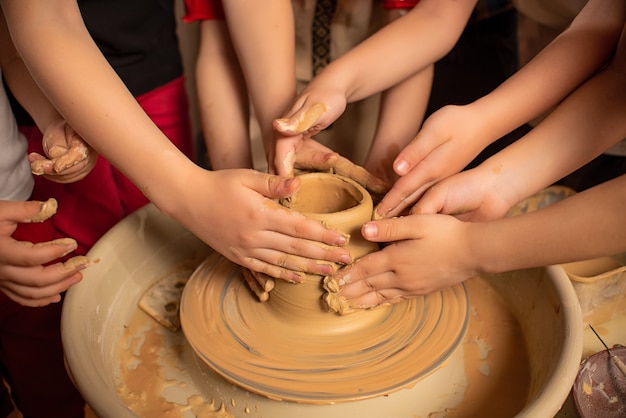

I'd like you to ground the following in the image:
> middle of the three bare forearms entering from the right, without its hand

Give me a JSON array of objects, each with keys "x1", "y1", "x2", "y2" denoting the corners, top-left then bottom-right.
[{"x1": 472, "y1": 42, "x2": 626, "y2": 204}]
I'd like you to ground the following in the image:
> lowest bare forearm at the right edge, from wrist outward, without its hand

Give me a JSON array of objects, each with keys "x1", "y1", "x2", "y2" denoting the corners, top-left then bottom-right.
[{"x1": 468, "y1": 176, "x2": 626, "y2": 273}]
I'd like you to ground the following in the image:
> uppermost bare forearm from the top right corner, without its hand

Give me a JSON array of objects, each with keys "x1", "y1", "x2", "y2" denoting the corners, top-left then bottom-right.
[{"x1": 469, "y1": 0, "x2": 626, "y2": 143}]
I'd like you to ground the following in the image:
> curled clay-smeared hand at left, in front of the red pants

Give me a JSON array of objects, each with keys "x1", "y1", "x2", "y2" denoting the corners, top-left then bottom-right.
[{"x1": 28, "y1": 120, "x2": 98, "y2": 183}]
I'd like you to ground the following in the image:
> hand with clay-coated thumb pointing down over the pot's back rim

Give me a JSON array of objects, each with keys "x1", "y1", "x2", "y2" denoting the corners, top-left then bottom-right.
[{"x1": 270, "y1": 86, "x2": 347, "y2": 177}]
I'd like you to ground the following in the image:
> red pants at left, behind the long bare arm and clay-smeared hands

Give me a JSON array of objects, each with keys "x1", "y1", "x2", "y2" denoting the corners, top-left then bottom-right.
[{"x1": 0, "y1": 77, "x2": 193, "y2": 418}]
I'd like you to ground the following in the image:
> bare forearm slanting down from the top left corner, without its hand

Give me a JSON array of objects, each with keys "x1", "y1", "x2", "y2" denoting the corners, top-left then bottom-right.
[{"x1": 1, "y1": 0, "x2": 193, "y2": 214}]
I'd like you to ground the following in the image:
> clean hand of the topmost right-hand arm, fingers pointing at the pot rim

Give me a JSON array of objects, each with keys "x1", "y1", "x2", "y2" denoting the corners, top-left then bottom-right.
[{"x1": 375, "y1": 106, "x2": 486, "y2": 218}]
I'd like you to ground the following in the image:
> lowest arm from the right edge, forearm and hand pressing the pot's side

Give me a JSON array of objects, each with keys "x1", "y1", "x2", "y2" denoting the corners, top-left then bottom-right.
[{"x1": 334, "y1": 176, "x2": 626, "y2": 308}]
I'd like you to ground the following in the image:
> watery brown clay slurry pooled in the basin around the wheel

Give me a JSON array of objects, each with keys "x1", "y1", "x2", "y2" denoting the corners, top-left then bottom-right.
[{"x1": 115, "y1": 278, "x2": 530, "y2": 418}]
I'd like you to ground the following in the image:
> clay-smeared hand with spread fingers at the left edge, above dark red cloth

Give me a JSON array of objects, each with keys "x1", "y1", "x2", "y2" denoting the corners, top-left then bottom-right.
[{"x1": 0, "y1": 199, "x2": 89, "y2": 306}]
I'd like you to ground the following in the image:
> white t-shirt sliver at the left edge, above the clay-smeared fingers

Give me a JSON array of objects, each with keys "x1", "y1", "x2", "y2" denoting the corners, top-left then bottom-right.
[{"x1": 0, "y1": 69, "x2": 34, "y2": 200}]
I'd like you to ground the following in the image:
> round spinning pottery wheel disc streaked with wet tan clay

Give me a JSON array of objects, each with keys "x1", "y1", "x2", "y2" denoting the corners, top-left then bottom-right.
[{"x1": 180, "y1": 254, "x2": 469, "y2": 404}]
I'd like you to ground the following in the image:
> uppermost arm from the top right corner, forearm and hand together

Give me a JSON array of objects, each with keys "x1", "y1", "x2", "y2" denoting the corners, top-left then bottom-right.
[{"x1": 377, "y1": 0, "x2": 626, "y2": 217}]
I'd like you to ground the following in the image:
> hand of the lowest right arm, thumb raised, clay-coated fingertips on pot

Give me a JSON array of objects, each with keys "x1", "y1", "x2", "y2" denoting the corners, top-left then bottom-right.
[{"x1": 333, "y1": 215, "x2": 477, "y2": 309}]
